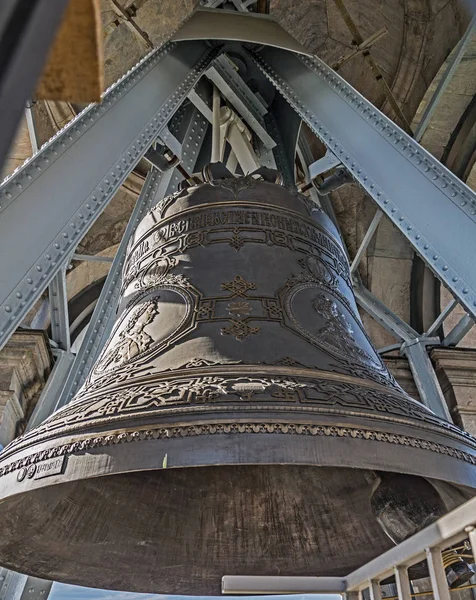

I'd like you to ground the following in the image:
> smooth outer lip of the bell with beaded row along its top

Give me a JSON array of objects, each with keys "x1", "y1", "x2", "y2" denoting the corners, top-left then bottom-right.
[{"x1": 0, "y1": 420, "x2": 476, "y2": 502}]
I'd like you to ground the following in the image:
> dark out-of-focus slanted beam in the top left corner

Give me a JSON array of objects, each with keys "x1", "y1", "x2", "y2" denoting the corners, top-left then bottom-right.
[{"x1": 0, "y1": 0, "x2": 68, "y2": 173}]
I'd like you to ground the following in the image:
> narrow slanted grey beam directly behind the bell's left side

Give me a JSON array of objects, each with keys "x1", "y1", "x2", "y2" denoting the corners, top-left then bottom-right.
[{"x1": 57, "y1": 169, "x2": 171, "y2": 408}]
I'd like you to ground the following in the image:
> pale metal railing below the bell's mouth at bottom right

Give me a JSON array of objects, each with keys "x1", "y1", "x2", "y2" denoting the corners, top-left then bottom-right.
[{"x1": 222, "y1": 498, "x2": 476, "y2": 600}]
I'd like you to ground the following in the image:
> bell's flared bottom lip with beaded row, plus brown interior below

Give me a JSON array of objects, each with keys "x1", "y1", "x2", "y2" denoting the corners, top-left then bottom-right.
[{"x1": 0, "y1": 408, "x2": 476, "y2": 595}]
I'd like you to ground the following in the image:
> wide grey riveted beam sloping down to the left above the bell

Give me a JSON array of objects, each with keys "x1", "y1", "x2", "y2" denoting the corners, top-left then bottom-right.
[{"x1": 0, "y1": 42, "x2": 216, "y2": 347}]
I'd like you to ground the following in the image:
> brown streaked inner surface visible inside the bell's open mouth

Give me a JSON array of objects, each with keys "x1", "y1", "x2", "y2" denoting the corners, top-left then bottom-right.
[{"x1": 0, "y1": 465, "x2": 392, "y2": 595}]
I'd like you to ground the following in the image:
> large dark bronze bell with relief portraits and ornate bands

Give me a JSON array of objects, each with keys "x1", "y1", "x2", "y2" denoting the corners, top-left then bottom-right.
[{"x1": 0, "y1": 171, "x2": 476, "y2": 594}]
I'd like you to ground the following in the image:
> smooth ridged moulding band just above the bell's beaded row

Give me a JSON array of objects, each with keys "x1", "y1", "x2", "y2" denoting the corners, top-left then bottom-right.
[{"x1": 0, "y1": 397, "x2": 476, "y2": 464}]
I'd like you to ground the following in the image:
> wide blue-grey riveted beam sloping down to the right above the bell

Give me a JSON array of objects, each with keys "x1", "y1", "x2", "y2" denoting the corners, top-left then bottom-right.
[{"x1": 254, "y1": 47, "x2": 476, "y2": 324}]
